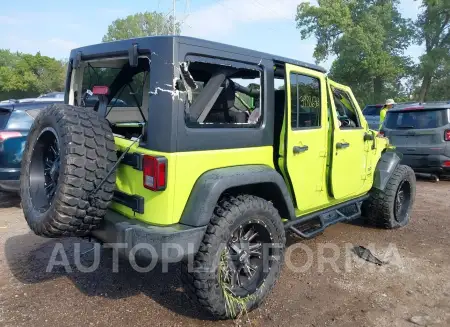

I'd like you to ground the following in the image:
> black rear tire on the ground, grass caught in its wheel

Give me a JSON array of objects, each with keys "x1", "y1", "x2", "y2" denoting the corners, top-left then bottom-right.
[{"x1": 181, "y1": 195, "x2": 286, "y2": 319}]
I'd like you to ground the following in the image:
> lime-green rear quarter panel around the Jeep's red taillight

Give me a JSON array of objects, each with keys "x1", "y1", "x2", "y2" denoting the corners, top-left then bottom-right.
[{"x1": 112, "y1": 138, "x2": 273, "y2": 225}]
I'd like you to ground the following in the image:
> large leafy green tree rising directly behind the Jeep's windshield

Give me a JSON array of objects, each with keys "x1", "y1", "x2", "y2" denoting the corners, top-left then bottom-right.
[{"x1": 296, "y1": 0, "x2": 414, "y2": 102}]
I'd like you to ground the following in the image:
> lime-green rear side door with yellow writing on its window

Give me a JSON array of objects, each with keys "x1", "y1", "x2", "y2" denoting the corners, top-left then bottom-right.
[{"x1": 284, "y1": 64, "x2": 328, "y2": 214}]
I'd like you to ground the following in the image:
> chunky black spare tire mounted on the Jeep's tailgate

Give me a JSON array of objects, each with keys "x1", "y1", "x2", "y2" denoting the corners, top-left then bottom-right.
[{"x1": 20, "y1": 104, "x2": 117, "y2": 237}]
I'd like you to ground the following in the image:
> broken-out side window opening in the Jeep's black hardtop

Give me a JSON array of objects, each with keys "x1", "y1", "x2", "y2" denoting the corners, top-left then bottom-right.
[{"x1": 181, "y1": 61, "x2": 263, "y2": 128}]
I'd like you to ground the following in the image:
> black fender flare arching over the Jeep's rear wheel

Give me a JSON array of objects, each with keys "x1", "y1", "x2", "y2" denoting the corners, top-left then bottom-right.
[{"x1": 180, "y1": 165, "x2": 295, "y2": 227}]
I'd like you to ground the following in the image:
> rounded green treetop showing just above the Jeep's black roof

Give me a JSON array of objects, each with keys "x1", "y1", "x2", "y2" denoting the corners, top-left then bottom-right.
[{"x1": 102, "y1": 11, "x2": 180, "y2": 42}]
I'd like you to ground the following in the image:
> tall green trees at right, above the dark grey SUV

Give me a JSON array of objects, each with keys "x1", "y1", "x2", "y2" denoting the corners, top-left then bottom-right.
[{"x1": 296, "y1": 0, "x2": 450, "y2": 103}]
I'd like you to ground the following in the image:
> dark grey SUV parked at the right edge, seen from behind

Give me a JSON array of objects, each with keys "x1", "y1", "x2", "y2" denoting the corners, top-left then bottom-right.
[{"x1": 380, "y1": 102, "x2": 450, "y2": 176}]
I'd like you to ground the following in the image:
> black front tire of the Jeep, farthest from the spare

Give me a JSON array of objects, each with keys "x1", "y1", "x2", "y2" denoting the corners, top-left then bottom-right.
[{"x1": 361, "y1": 165, "x2": 416, "y2": 229}]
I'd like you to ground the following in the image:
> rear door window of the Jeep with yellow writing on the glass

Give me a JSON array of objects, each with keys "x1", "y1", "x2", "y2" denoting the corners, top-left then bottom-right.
[{"x1": 290, "y1": 73, "x2": 322, "y2": 129}]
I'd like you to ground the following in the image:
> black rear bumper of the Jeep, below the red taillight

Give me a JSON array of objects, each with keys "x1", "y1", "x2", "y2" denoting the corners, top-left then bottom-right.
[{"x1": 92, "y1": 210, "x2": 207, "y2": 262}]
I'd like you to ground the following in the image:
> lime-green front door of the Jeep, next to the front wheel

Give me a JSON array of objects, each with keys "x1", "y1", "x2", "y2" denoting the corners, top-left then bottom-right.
[{"x1": 328, "y1": 80, "x2": 368, "y2": 199}]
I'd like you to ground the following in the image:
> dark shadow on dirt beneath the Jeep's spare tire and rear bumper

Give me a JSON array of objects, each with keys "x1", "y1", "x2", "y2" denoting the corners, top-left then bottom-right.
[{"x1": 5, "y1": 233, "x2": 214, "y2": 320}]
